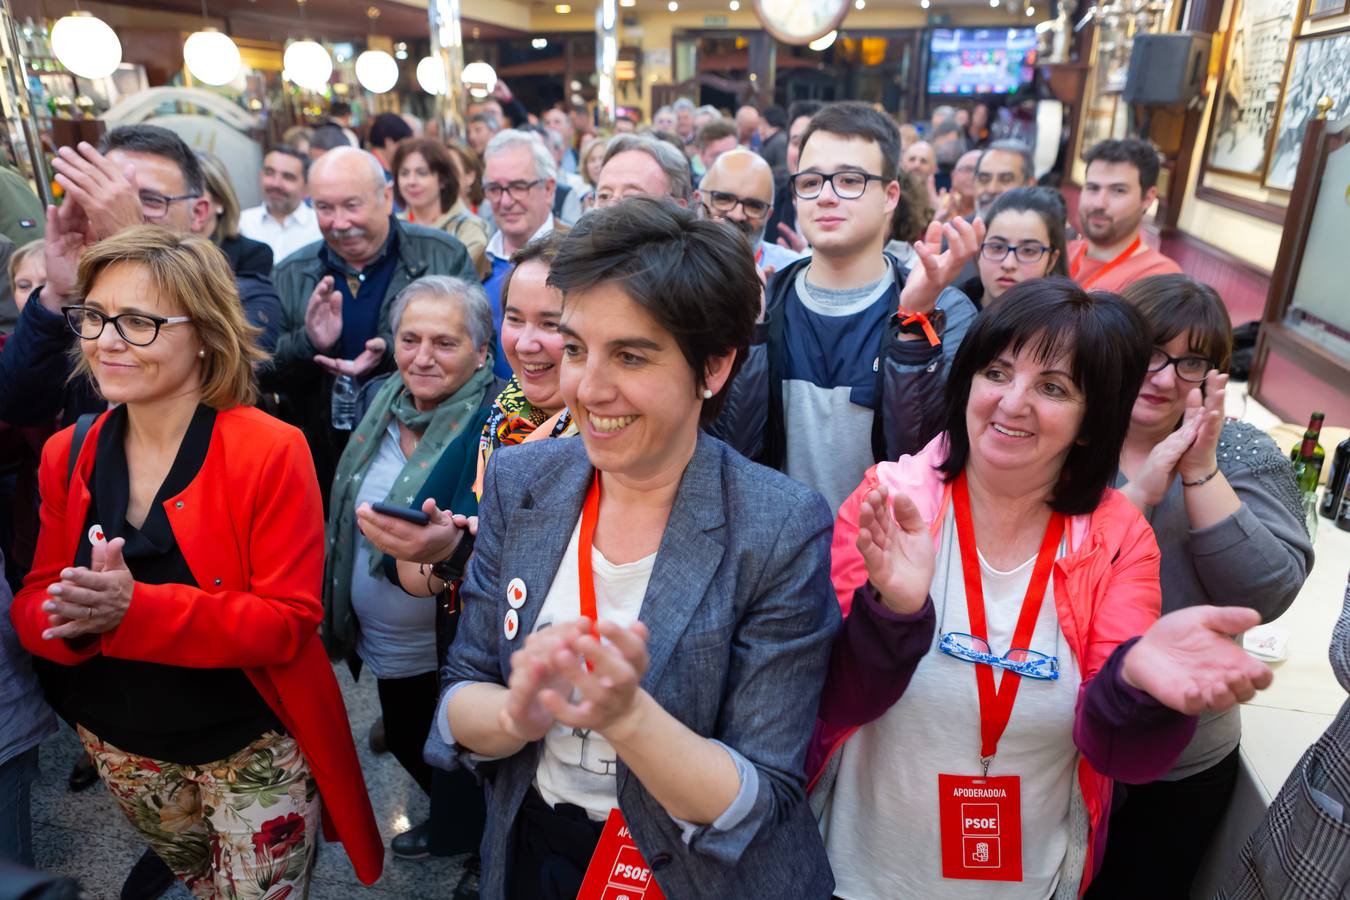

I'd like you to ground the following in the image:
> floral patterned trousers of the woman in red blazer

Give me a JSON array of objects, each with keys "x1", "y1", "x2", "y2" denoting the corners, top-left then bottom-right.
[{"x1": 78, "y1": 727, "x2": 320, "y2": 900}]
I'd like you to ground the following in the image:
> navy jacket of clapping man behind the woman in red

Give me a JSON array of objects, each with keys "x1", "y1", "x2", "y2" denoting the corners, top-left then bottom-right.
[{"x1": 0, "y1": 274, "x2": 281, "y2": 426}]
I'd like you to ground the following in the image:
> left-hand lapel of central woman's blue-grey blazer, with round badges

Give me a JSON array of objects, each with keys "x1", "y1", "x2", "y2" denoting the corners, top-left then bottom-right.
[{"x1": 493, "y1": 439, "x2": 594, "y2": 655}]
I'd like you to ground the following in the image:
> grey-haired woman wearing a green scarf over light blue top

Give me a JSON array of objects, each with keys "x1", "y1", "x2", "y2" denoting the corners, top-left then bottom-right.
[{"x1": 323, "y1": 275, "x2": 500, "y2": 857}]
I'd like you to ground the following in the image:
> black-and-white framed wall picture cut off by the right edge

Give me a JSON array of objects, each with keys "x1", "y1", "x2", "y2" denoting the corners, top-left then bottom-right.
[{"x1": 1262, "y1": 28, "x2": 1350, "y2": 190}]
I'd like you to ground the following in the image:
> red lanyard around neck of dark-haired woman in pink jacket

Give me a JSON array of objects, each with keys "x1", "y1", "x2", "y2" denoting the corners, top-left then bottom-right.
[{"x1": 952, "y1": 472, "x2": 1064, "y2": 773}]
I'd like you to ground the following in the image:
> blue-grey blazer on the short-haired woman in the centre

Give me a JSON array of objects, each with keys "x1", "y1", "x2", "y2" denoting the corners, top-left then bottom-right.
[{"x1": 441, "y1": 434, "x2": 840, "y2": 900}]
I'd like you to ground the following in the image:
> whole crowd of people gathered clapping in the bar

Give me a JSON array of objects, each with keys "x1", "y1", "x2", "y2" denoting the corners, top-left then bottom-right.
[{"x1": 0, "y1": 82, "x2": 1314, "y2": 900}]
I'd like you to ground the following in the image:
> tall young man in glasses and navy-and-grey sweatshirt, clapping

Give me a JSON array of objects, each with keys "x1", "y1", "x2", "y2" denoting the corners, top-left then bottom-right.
[{"x1": 714, "y1": 103, "x2": 984, "y2": 509}]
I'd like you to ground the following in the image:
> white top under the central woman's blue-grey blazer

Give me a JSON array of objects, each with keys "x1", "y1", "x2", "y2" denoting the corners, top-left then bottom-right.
[{"x1": 535, "y1": 521, "x2": 656, "y2": 822}]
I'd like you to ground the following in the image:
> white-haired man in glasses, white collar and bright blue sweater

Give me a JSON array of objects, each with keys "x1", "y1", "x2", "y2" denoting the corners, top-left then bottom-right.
[{"x1": 483, "y1": 129, "x2": 566, "y2": 378}]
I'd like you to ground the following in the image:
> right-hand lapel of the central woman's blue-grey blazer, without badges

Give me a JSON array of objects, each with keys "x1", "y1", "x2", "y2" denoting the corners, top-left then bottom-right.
[{"x1": 640, "y1": 433, "x2": 726, "y2": 692}]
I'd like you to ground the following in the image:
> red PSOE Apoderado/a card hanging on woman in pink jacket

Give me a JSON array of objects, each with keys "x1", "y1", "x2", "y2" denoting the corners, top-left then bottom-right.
[{"x1": 939, "y1": 775, "x2": 1022, "y2": 881}]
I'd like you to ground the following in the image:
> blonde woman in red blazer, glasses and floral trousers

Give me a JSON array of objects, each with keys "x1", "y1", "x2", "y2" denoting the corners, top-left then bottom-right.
[{"x1": 12, "y1": 225, "x2": 383, "y2": 899}]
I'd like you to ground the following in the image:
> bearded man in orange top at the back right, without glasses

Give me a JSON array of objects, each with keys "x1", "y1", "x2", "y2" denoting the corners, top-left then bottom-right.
[{"x1": 1069, "y1": 138, "x2": 1181, "y2": 293}]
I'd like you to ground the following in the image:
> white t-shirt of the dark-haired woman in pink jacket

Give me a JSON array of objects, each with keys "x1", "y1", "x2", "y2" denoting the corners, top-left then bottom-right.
[{"x1": 821, "y1": 510, "x2": 1081, "y2": 900}]
